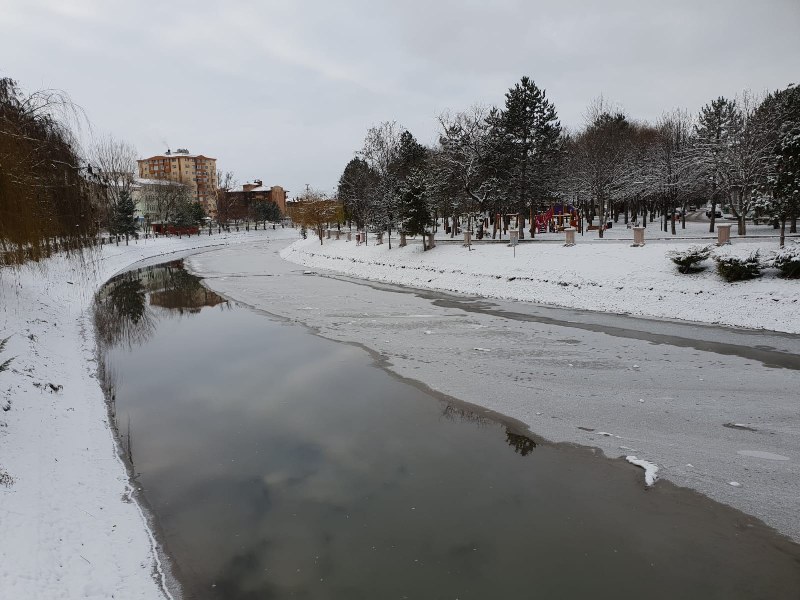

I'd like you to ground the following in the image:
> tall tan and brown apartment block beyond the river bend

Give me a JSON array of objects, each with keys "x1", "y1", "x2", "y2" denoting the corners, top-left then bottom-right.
[{"x1": 137, "y1": 149, "x2": 217, "y2": 216}]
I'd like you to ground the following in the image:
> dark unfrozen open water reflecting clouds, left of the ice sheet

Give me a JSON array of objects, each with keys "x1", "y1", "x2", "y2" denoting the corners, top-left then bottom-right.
[{"x1": 98, "y1": 266, "x2": 800, "y2": 600}]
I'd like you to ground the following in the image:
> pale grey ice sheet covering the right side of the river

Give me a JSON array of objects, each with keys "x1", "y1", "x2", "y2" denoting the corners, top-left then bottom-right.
[{"x1": 188, "y1": 242, "x2": 800, "y2": 540}]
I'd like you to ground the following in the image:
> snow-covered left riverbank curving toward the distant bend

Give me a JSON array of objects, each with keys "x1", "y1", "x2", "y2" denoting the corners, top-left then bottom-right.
[{"x1": 0, "y1": 230, "x2": 296, "y2": 600}]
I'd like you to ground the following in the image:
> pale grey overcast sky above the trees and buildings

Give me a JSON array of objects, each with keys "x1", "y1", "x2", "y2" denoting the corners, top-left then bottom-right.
[{"x1": 0, "y1": 0, "x2": 800, "y2": 195}]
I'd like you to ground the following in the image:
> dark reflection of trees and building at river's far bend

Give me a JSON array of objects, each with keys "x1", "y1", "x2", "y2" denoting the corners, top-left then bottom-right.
[{"x1": 94, "y1": 260, "x2": 228, "y2": 348}]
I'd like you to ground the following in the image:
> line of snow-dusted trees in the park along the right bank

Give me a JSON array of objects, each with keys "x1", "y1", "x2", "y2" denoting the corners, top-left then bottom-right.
[{"x1": 337, "y1": 77, "x2": 800, "y2": 245}]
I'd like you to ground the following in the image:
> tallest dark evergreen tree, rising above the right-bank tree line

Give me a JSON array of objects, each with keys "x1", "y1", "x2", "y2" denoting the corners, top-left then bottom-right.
[{"x1": 490, "y1": 77, "x2": 561, "y2": 231}]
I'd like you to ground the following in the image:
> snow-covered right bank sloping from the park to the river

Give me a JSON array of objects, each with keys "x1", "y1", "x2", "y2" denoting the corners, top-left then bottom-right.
[{"x1": 281, "y1": 222, "x2": 800, "y2": 333}]
